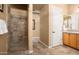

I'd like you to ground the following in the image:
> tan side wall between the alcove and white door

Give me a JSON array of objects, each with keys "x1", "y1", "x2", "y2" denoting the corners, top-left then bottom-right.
[{"x1": 40, "y1": 5, "x2": 49, "y2": 46}]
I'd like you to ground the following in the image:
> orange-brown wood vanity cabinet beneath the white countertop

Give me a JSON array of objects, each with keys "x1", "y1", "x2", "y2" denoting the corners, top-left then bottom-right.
[{"x1": 63, "y1": 33, "x2": 79, "y2": 50}]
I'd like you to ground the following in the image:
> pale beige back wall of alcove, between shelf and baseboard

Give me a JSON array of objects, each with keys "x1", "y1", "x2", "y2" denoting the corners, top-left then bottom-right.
[{"x1": 33, "y1": 13, "x2": 40, "y2": 37}]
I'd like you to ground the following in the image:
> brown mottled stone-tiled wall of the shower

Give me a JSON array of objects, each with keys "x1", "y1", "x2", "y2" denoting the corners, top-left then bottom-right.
[{"x1": 8, "y1": 9, "x2": 28, "y2": 51}]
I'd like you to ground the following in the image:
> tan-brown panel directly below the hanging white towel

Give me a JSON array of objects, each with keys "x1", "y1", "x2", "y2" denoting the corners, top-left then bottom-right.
[{"x1": 0, "y1": 35, "x2": 8, "y2": 54}]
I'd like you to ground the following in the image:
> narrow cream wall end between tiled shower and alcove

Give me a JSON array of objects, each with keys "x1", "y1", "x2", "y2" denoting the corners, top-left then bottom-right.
[{"x1": 28, "y1": 4, "x2": 33, "y2": 53}]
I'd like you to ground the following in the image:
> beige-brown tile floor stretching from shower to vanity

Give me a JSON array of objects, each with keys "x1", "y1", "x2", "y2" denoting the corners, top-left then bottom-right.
[{"x1": 9, "y1": 43, "x2": 79, "y2": 55}]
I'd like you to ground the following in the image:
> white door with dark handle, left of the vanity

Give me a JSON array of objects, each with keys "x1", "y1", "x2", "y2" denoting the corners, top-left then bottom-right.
[{"x1": 51, "y1": 7, "x2": 63, "y2": 47}]
